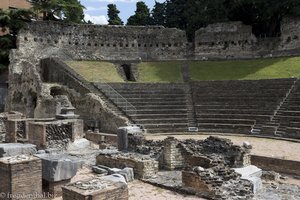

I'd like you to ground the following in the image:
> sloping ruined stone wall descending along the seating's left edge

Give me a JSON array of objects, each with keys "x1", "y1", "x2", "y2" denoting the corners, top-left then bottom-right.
[{"x1": 36, "y1": 58, "x2": 129, "y2": 132}]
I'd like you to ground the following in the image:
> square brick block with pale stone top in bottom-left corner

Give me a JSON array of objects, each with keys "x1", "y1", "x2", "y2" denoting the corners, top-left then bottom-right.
[{"x1": 0, "y1": 155, "x2": 42, "y2": 200}]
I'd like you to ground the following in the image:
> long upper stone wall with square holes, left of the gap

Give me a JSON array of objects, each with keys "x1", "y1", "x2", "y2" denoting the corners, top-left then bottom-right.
[{"x1": 19, "y1": 22, "x2": 187, "y2": 60}]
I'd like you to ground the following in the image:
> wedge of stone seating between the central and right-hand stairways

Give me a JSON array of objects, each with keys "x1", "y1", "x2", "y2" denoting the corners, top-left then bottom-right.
[{"x1": 192, "y1": 79, "x2": 295, "y2": 134}]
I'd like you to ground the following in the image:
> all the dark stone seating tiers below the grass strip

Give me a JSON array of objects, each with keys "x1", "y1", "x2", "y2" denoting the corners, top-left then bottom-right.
[{"x1": 94, "y1": 79, "x2": 300, "y2": 139}]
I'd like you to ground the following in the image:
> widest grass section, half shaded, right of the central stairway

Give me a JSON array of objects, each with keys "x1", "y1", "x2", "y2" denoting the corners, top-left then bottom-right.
[{"x1": 190, "y1": 57, "x2": 300, "y2": 80}]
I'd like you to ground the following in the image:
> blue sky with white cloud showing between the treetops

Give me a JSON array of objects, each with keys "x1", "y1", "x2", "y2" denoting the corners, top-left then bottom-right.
[{"x1": 80, "y1": 0, "x2": 164, "y2": 24}]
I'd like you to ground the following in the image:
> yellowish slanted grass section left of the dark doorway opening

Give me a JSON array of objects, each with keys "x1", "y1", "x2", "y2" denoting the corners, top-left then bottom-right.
[{"x1": 66, "y1": 61, "x2": 124, "y2": 82}]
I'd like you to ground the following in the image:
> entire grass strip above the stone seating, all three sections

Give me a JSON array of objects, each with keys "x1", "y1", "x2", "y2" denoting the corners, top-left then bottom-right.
[{"x1": 66, "y1": 57, "x2": 300, "y2": 83}]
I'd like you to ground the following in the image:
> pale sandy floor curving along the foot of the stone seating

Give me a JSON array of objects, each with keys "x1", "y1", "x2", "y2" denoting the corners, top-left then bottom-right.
[{"x1": 146, "y1": 135, "x2": 300, "y2": 161}]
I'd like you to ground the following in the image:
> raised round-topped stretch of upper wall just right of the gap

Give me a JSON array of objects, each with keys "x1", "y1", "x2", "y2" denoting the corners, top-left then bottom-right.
[{"x1": 195, "y1": 22, "x2": 256, "y2": 60}]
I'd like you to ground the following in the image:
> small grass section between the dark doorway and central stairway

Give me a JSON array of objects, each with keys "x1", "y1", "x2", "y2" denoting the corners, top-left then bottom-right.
[{"x1": 138, "y1": 61, "x2": 182, "y2": 83}]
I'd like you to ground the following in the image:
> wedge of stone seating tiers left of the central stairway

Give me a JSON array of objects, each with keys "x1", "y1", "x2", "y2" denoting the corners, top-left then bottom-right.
[{"x1": 102, "y1": 83, "x2": 188, "y2": 133}]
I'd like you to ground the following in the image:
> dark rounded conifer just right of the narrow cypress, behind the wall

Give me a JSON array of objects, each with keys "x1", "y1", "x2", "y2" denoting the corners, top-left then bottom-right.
[{"x1": 127, "y1": 1, "x2": 151, "y2": 26}]
